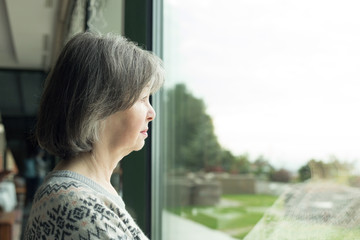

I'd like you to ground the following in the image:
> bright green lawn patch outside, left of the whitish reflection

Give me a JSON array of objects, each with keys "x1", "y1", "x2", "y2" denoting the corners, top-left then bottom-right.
[{"x1": 170, "y1": 195, "x2": 277, "y2": 239}]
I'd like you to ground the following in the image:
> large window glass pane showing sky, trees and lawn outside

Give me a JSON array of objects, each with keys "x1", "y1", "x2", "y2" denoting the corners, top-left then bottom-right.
[{"x1": 160, "y1": 0, "x2": 360, "y2": 240}]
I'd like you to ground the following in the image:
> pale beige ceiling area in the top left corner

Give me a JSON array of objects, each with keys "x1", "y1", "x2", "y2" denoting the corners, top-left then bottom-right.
[{"x1": 0, "y1": 0, "x2": 58, "y2": 70}]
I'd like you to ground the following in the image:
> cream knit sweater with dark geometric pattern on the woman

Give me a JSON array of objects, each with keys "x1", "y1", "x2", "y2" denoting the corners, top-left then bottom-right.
[{"x1": 24, "y1": 171, "x2": 148, "y2": 240}]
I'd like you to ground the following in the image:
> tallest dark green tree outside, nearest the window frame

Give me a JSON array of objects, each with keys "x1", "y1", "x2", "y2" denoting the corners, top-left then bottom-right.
[{"x1": 167, "y1": 84, "x2": 224, "y2": 171}]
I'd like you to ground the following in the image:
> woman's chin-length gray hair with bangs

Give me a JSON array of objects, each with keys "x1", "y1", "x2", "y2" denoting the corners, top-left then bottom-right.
[{"x1": 35, "y1": 32, "x2": 164, "y2": 159}]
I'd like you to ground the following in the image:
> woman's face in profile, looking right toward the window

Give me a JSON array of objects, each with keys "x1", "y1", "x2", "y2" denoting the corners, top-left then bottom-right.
[{"x1": 101, "y1": 88, "x2": 156, "y2": 157}]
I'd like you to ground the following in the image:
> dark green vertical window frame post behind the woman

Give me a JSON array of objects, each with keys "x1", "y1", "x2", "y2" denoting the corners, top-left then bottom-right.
[{"x1": 121, "y1": 0, "x2": 153, "y2": 236}]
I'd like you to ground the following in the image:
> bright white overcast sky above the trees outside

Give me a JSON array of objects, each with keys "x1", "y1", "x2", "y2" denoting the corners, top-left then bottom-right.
[{"x1": 164, "y1": 0, "x2": 360, "y2": 170}]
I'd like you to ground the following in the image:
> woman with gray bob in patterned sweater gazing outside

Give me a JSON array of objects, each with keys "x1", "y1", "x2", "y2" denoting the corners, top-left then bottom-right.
[{"x1": 24, "y1": 33, "x2": 163, "y2": 240}]
